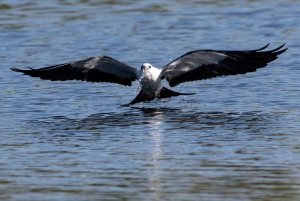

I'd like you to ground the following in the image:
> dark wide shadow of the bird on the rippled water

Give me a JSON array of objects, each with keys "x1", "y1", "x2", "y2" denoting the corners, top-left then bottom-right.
[{"x1": 29, "y1": 107, "x2": 271, "y2": 131}]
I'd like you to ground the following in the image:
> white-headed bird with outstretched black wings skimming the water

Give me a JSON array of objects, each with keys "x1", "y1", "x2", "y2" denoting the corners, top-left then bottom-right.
[{"x1": 11, "y1": 44, "x2": 288, "y2": 106}]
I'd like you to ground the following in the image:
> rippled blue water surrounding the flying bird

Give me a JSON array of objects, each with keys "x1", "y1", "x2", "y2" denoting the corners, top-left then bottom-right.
[{"x1": 0, "y1": 0, "x2": 300, "y2": 201}]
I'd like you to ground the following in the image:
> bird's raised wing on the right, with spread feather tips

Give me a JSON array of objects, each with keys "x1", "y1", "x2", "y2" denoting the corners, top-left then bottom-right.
[{"x1": 161, "y1": 44, "x2": 287, "y2": 86}]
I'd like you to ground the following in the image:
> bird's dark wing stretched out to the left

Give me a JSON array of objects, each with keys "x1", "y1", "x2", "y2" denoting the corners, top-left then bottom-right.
[{"x1": 11, "y1": 56, "x2": 137, "y2": 86}]
